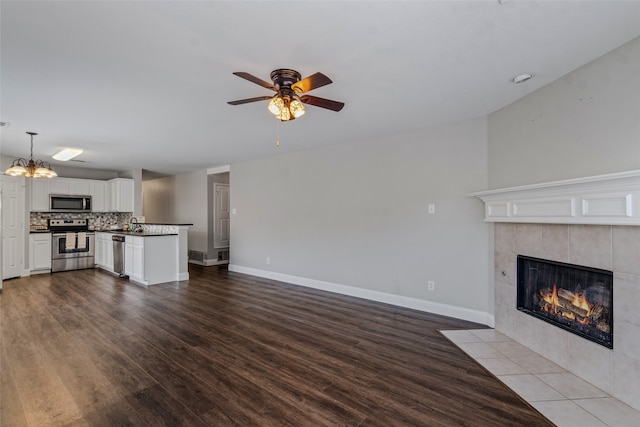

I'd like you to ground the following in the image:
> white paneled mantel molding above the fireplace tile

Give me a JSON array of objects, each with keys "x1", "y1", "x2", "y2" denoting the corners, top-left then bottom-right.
[{"x1": 470, "y1": 170, "x2": 640, "y2": 225}]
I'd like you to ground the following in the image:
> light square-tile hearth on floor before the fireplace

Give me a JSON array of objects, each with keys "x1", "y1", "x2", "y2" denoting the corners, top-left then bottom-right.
[{"x1": 441, "y1": 329, "x2": 640, "y2": 427}]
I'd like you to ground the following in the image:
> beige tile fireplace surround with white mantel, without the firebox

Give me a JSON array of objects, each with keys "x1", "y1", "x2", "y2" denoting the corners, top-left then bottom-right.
[{"x1": 473, "y1": 171, "x2": 640, "y2": 410}]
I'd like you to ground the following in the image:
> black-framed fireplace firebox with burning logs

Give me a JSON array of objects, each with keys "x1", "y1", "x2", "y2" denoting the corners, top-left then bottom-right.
[{"x1": 517, "y1": 255, "x2": 613, "y2": 348}]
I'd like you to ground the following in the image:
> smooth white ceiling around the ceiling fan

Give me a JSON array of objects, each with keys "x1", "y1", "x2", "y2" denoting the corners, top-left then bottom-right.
[{"x1": 0, "y1": 0, "x2": 640, "y2": 174}]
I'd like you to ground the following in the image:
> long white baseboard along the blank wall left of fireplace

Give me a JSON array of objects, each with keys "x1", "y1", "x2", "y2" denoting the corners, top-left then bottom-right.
[{"x1": 229, "y1": 264, "x2": 495, "y2": 327}]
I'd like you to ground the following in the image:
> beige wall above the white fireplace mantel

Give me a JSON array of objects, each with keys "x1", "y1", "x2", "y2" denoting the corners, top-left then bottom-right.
[{"x1": 489, "y1": 38, "x2": 640, "y2": 189}]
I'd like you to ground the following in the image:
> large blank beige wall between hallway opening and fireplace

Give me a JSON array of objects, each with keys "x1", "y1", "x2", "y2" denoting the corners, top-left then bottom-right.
[{"x1": 231, "y1": 119, "x2": 493, "y2": 313}]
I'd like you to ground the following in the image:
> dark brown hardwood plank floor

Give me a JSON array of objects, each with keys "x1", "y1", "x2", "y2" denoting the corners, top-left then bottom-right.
[{"x1": 0, "y1": 265, "x2": 552, "y2": 427}]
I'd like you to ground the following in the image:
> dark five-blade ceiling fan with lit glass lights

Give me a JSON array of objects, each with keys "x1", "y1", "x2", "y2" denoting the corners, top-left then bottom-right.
[{"x1": 228, "y1": 68, "x2": 344, "y2": 122}]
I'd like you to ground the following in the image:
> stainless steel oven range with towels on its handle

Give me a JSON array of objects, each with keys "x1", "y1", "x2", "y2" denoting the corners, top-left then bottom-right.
[{"x1": 49, "y1": 219, "x2": 95, "y2": 272}]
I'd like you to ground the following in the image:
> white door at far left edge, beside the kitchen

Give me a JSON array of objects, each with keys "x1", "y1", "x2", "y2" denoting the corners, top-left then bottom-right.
[{"x1": 1, "y1": 175, "x2": 25, "y2": 279}]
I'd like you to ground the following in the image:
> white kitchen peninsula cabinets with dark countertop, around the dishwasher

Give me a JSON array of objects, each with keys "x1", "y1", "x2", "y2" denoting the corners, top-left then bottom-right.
[{"x1": 96, "y1": 224, "x2": 191, "y2": 285}]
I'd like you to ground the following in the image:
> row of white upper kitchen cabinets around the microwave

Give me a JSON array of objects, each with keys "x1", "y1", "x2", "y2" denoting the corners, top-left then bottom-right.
[{"x1": 29, "y1": 178, "x2": 134, "y2": 212}]
